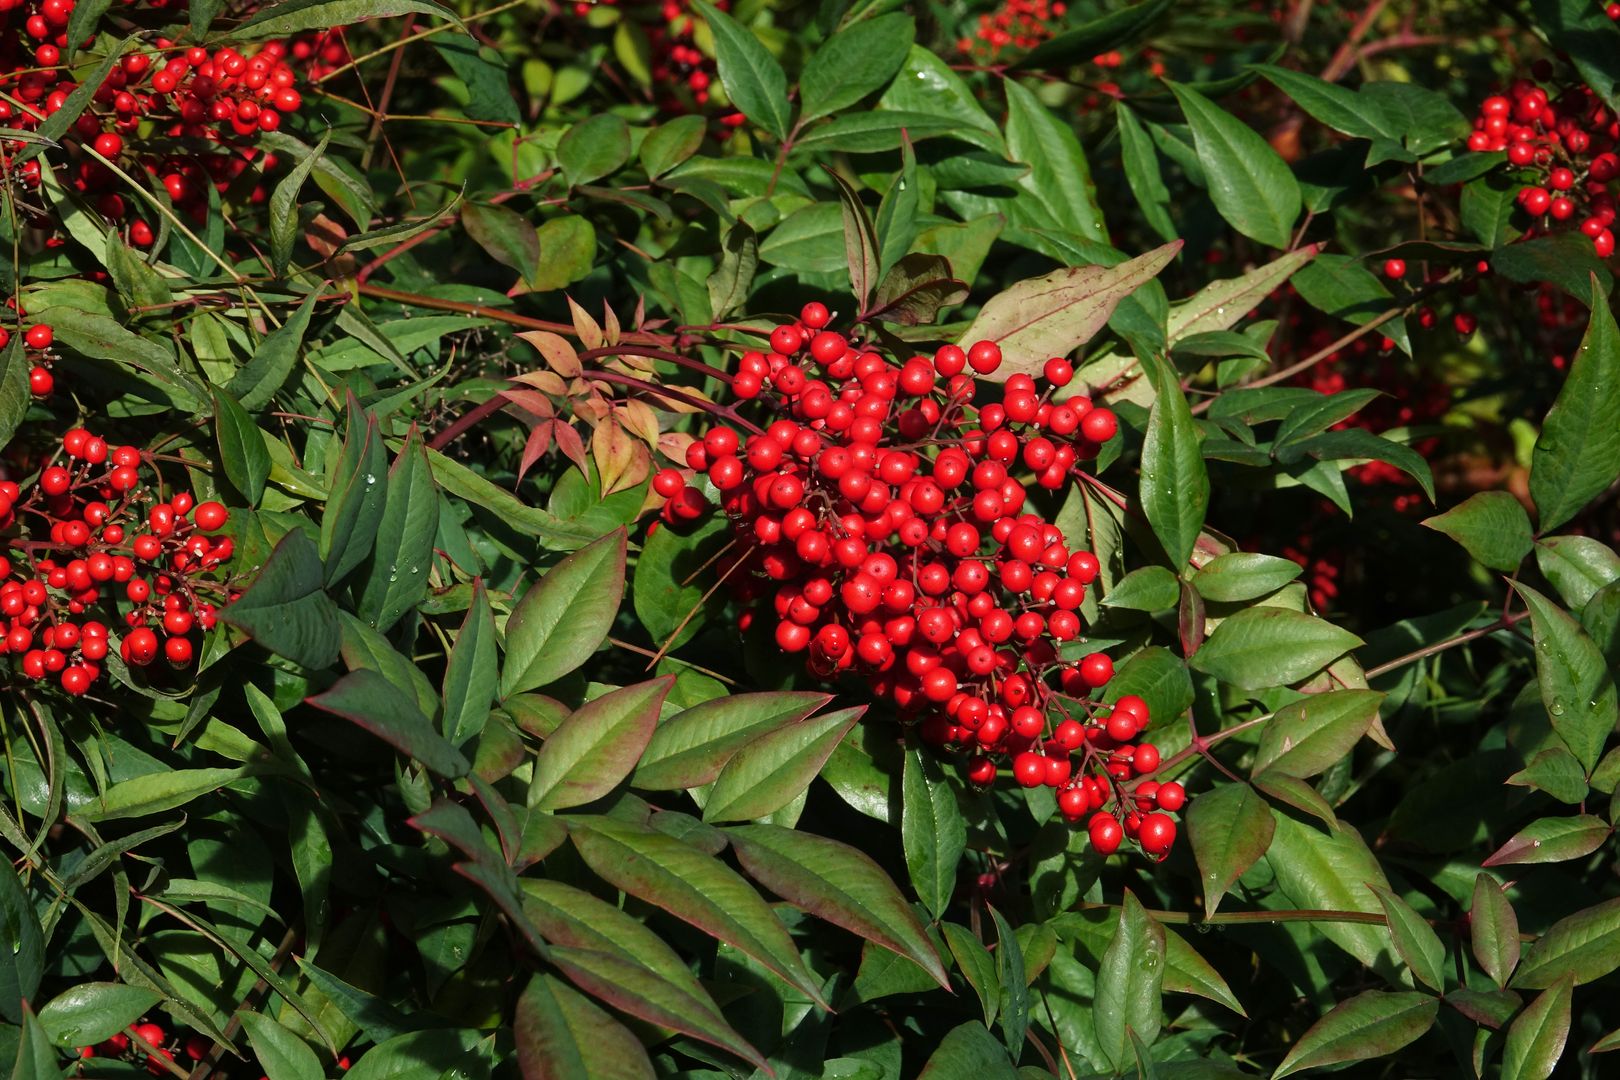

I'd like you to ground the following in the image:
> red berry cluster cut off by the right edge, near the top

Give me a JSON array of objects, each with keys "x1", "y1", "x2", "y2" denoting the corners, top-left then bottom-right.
[{"x1": 1468, "y1": 79, "x2": 1620, "y2": 259}]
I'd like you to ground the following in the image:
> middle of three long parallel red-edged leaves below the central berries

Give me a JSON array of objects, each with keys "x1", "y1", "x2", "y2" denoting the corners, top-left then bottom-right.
[{"x1": 569, "y1": 818, "x2": 825, "y2": 1007}]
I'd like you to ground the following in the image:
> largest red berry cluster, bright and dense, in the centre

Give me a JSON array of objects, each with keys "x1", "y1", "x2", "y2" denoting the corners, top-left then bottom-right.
[{"x1": 653, "y1": 303, "x2": 1186, "y2": 858}]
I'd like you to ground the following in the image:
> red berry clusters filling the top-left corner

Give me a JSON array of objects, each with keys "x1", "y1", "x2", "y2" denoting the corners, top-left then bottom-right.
[{"x1": 0, "y1": 10, "x2": 309, "y2": 248}]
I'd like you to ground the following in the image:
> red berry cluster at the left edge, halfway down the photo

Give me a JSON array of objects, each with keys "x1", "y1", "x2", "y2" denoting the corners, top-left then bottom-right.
[{"x1": 0, "y1": 427, "x2": 232, "y2": 695}]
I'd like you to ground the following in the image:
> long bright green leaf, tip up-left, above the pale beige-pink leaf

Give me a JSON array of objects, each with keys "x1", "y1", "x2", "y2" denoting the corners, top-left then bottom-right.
[{"x1": 1001, "y1": 79, "x2": 1108, "y2": 242}]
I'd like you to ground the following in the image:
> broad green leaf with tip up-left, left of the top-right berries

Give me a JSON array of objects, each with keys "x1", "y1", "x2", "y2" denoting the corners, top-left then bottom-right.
[{"x1": 1168, "y1": 83, "x2": 1301, "y2": 248}]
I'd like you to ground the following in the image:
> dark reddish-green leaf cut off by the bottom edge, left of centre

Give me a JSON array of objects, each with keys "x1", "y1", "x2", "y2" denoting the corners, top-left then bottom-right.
[{"x1": 512, "y1": 975, "x2": 653, "y2": 1080}]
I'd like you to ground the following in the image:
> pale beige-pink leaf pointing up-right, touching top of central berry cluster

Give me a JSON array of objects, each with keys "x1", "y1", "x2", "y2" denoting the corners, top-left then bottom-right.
[{"x1": 959, "y1": 240, "x2": 1181, "y2": 382}]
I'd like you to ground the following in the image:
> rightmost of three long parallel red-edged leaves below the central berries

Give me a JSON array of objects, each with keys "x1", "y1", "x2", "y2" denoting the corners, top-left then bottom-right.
[{"x1": 726, "y1": 824, "x2": 951, "y2": 989}]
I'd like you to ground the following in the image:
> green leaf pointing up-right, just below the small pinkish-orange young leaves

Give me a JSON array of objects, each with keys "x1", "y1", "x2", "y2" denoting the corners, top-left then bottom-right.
[{"x1": 501, "y1": 528, "x2": 629, "y2": 698}]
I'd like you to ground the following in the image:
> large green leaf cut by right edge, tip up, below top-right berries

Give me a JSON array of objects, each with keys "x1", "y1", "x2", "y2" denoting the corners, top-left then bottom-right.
[{"x1": 1529, "y1": 277, "x2": 1620, "y2": 533}]
